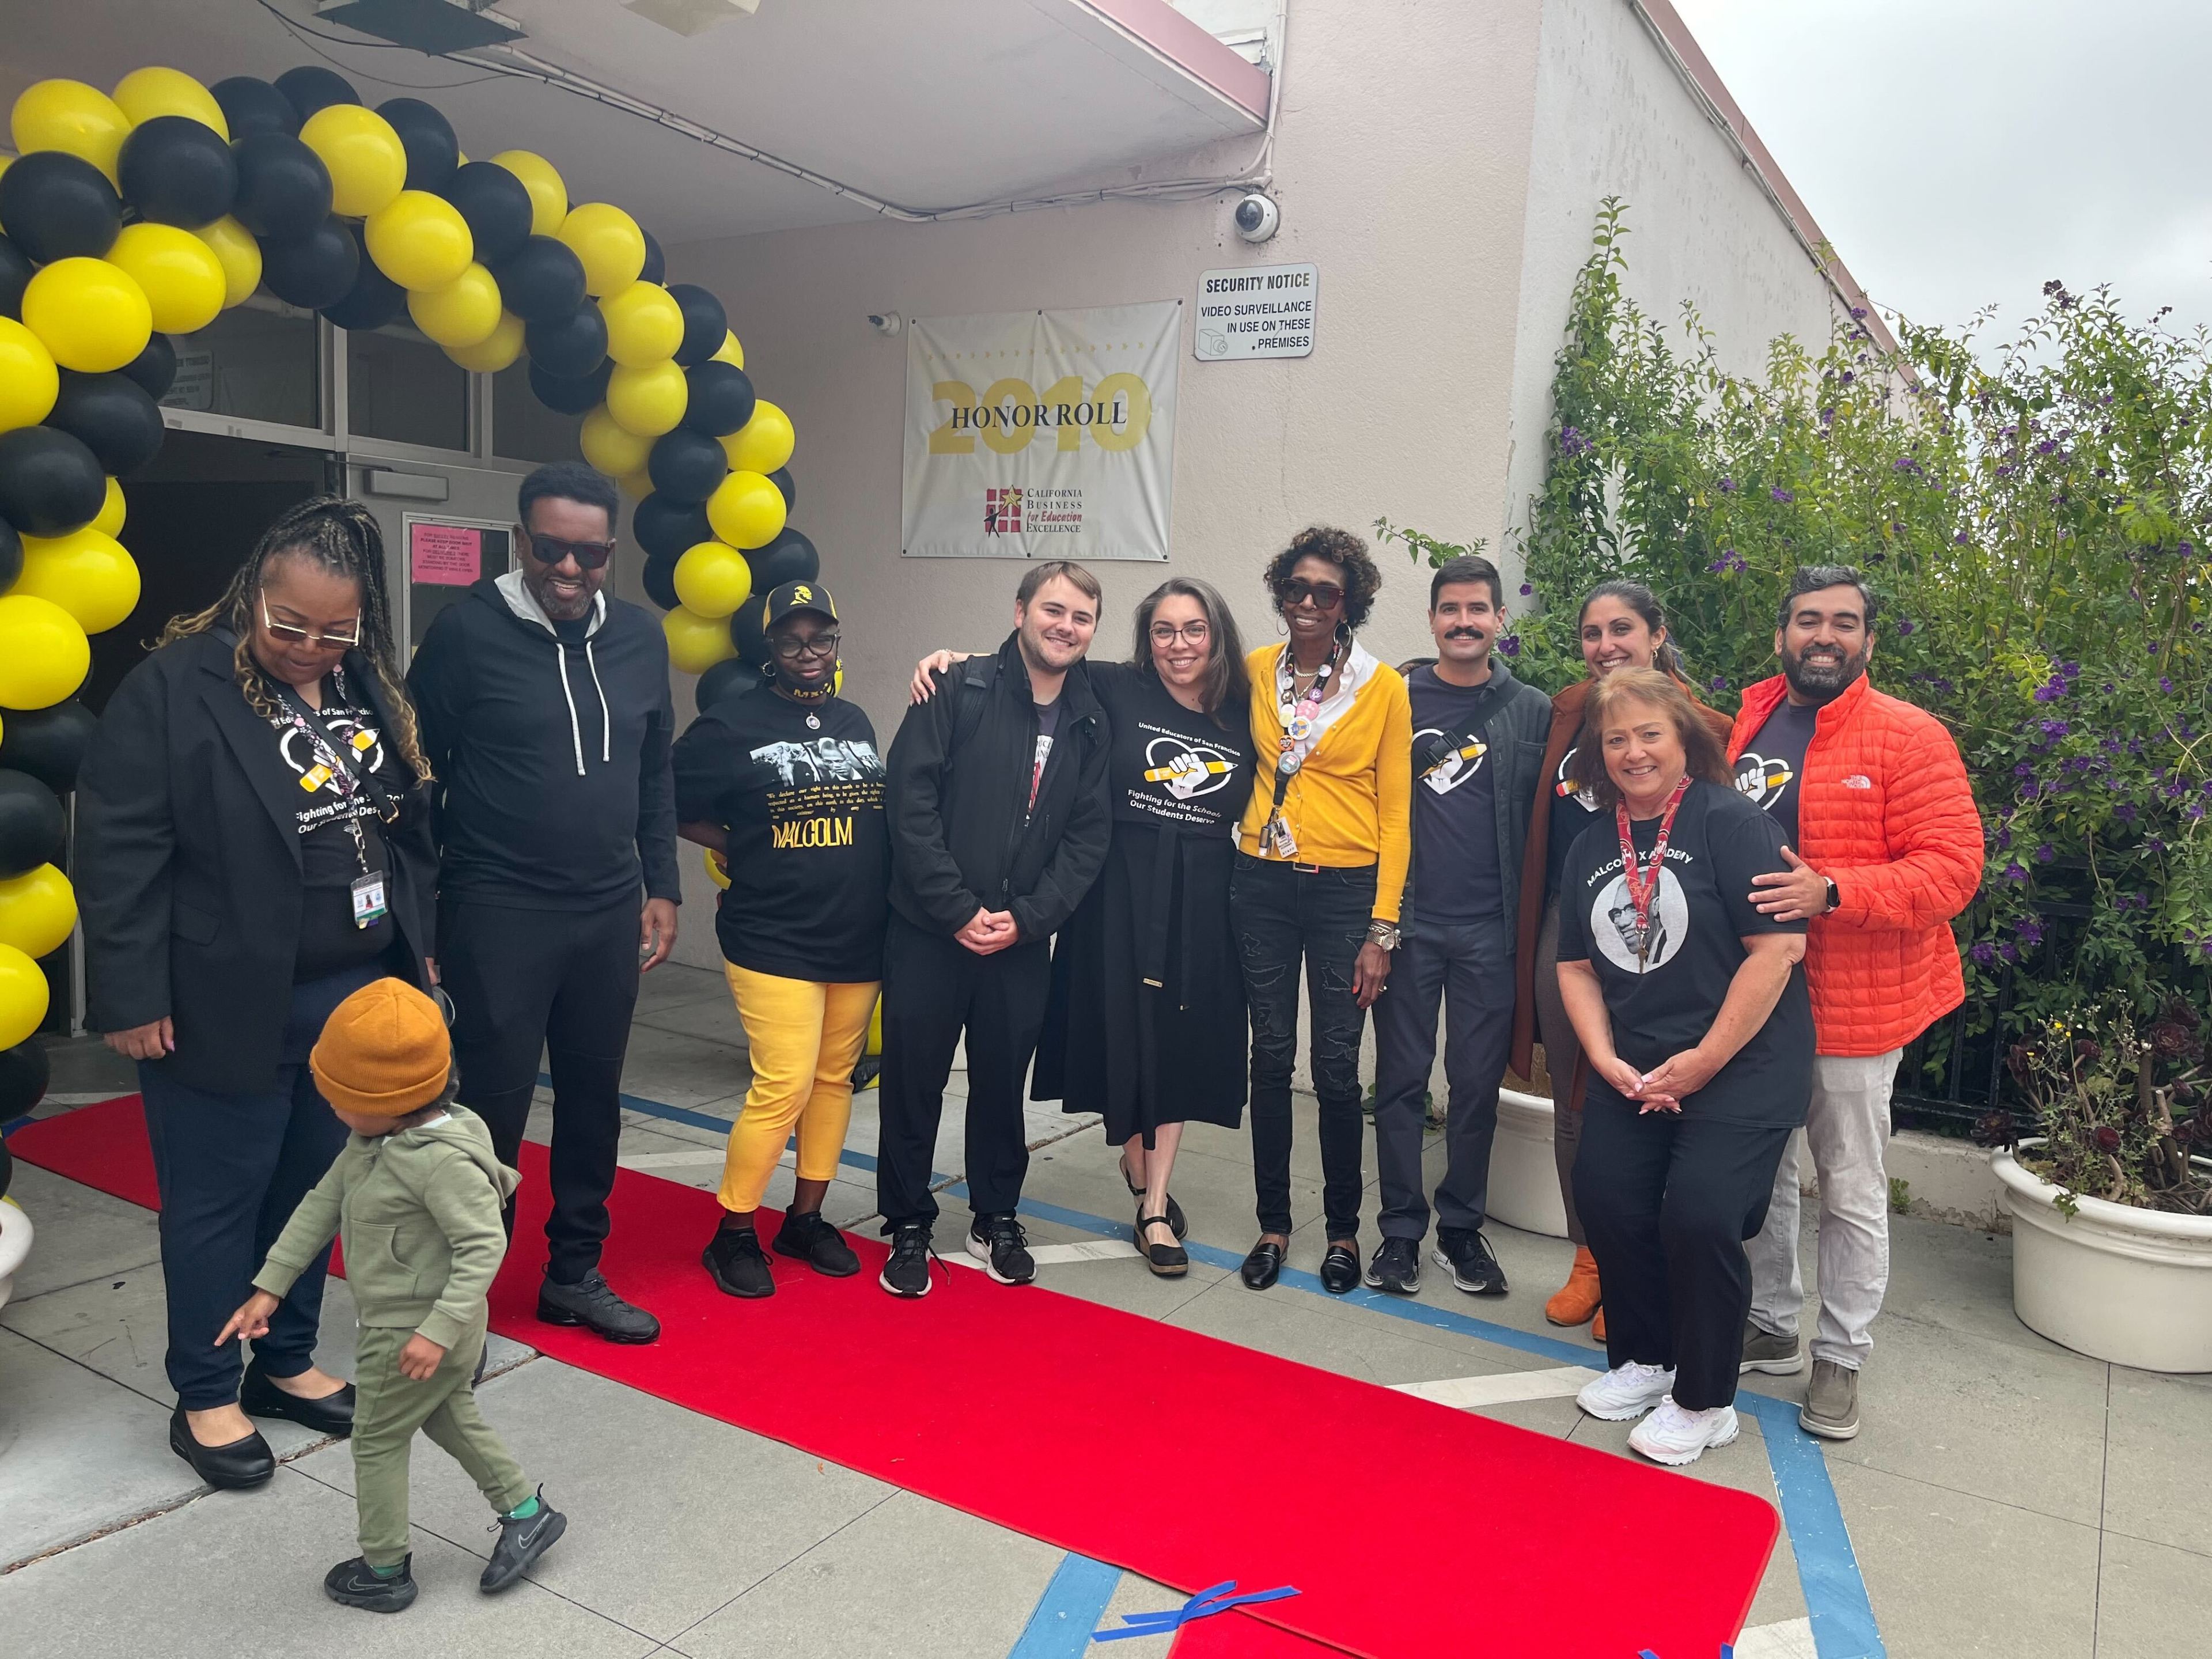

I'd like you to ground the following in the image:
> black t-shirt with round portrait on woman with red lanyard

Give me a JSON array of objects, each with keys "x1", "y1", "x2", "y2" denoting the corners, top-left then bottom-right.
[{"x1": 1559, "y1": 781, "x2": 1814, "y2": 1126}]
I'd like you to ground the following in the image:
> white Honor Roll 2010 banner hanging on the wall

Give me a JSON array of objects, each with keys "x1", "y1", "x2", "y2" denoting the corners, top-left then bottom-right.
[{"x1": 900, "y1": 301, "x2": 1183, "y2": 560}]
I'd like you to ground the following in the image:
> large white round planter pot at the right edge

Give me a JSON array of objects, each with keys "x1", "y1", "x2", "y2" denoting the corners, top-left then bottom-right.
[{"x1": 1988, "y1": 1141, "x2": 2212, "y2": 1372}]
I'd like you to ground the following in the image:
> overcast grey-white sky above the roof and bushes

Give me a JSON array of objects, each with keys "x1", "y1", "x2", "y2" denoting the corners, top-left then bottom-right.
[{"x1": 1675, "y1": 0, "x2": 2212, "y2": 345}]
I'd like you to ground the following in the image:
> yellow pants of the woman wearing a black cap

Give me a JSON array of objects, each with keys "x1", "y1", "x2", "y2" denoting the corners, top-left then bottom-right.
[{"x1": 717, "y1": 962, "x2": 882, "y2": 1214}]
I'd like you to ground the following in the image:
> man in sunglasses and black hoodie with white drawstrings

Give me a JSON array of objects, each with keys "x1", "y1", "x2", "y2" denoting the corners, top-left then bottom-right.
[{"x1": 407, "y1": 463, "x2": 679, "y2": 1343}]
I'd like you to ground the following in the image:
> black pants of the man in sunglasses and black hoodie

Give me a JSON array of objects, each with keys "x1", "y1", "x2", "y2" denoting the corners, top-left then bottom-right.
[{"x1": 438, "y1": 898, "x2": 642, "y2": 1285}]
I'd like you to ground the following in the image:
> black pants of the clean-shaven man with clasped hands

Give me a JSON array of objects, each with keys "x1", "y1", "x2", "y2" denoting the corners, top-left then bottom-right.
[{"x1": 876, "y1": 911, "x2": 1053, "y2": 1232}]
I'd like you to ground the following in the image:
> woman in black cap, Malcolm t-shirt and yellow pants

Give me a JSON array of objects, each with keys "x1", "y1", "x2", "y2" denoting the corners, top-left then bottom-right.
[{"x1": 675, "y1": 582, "x2": 892, "y2": 1296}]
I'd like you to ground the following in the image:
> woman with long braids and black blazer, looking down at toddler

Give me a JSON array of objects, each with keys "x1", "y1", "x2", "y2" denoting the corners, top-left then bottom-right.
[{"x1": 77, "y1": 495, "x2": 438, "y2": 1486}]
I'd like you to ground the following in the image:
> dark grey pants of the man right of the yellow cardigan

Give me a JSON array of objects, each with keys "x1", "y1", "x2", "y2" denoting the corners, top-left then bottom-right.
[{"x1": 1376, "y1": 916, "x2": 1513, "y2": 1238}]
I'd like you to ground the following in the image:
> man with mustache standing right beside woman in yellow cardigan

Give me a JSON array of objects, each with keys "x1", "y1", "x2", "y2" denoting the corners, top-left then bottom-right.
[{"x1": 1367, "y1": 558, "x2": 1551, "y2": 1296}]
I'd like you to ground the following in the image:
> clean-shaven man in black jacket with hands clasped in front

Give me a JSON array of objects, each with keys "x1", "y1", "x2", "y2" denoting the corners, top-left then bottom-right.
[{"x1": 876, "y1": 560, "x2": 1113, "y2": 1296}]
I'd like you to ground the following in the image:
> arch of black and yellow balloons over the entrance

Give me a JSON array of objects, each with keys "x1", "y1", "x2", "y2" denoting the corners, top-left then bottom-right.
[{"x1": 0, "y1": 66, "x2": 821, "y2": 1079}]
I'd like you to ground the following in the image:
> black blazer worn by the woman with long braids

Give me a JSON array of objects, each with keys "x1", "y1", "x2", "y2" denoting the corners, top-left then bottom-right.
[{"x1": 75, "y1": 632, "x2": 438, "y2": 1095}]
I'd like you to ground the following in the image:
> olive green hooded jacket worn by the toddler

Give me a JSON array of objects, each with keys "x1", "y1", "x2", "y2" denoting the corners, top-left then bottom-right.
[{"x1": 255, "y1": 1106, "x2": 522, "y2": 1347}]
